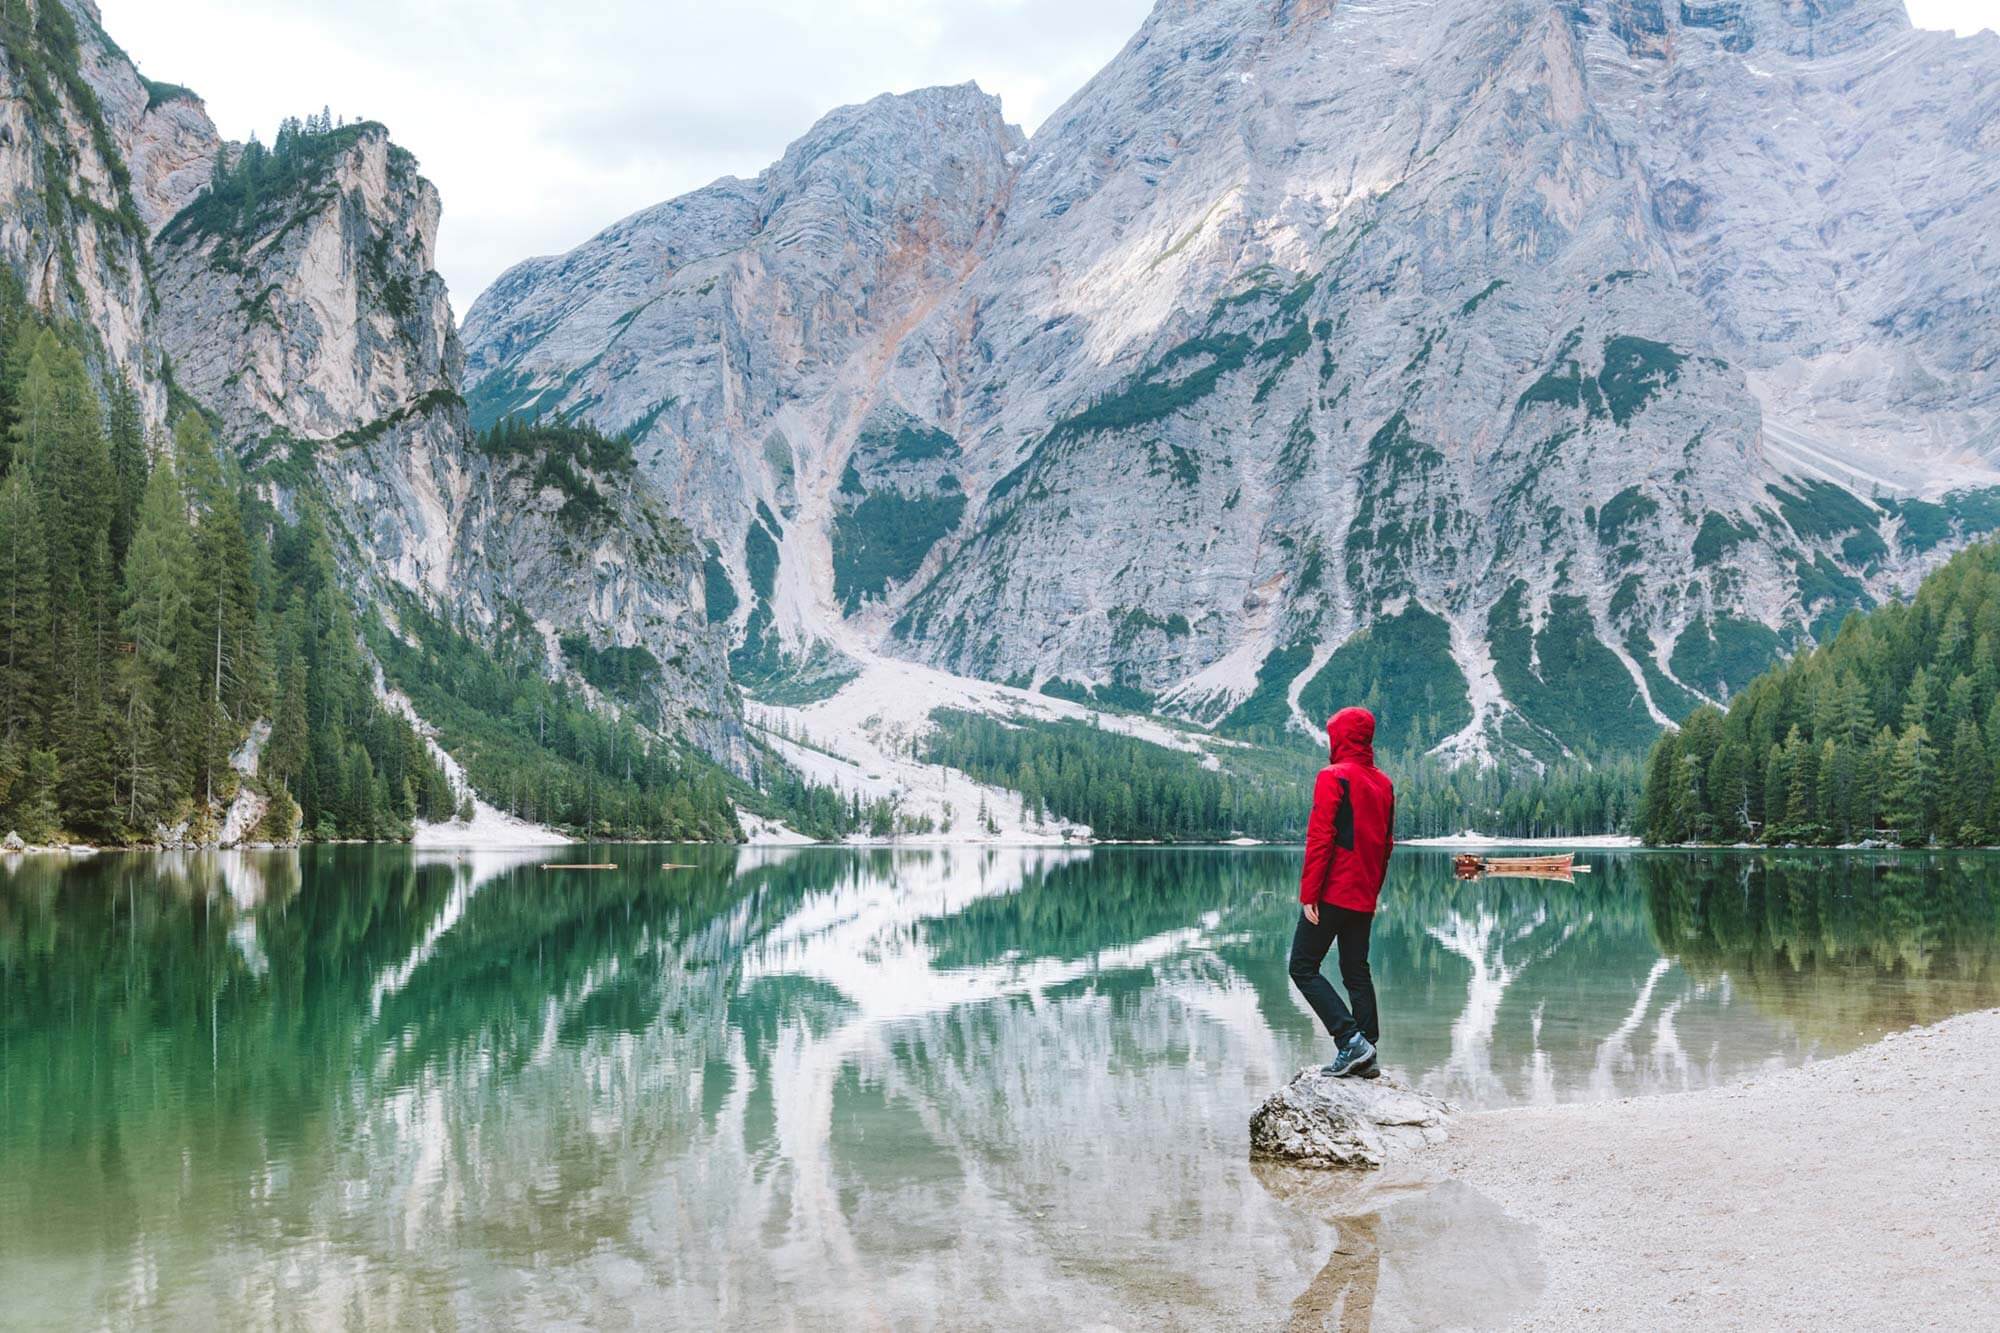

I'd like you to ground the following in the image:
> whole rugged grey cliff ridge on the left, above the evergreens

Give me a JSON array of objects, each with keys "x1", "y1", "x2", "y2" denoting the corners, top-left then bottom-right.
[{"x1": 0, "y1": 0, "x2": 742, "y2": 767}]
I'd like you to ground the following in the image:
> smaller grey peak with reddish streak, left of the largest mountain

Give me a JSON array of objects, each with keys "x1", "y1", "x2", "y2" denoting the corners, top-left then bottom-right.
[{"x1": 466, "y1": 86, "x2": 1022, "y2": 676}]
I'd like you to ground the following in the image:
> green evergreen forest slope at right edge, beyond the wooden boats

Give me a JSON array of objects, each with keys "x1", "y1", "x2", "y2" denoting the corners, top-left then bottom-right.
[{"x1": 1642, "y1": 544, "x2": 2000, "y2": 847}]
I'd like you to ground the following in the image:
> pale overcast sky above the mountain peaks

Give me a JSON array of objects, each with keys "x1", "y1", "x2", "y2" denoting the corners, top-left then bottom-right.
[{"x1": 98, "y1": 0, "x2": 2000, "y2": 314}]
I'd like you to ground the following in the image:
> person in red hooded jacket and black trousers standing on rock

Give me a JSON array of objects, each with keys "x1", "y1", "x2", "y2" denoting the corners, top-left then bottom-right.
[{"x1": 1292, "y1": 709, "x2": 1396, "y2": 1079}]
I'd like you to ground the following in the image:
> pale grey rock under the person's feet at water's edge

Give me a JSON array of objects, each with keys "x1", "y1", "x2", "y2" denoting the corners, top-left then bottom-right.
[{"x1": 1250, "y1": 1065, "x2": 1452, "y2": 1167}]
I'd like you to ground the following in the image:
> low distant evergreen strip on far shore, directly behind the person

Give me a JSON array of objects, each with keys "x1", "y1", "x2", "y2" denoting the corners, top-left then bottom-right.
[{"x1": 924, "y1": 709, "x2": 1640, "y2": 841}]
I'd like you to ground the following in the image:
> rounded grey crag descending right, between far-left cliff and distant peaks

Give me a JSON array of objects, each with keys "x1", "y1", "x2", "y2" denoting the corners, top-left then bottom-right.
[{"x1": 154, "y1": 124, "x2": 734, "y2": 755}]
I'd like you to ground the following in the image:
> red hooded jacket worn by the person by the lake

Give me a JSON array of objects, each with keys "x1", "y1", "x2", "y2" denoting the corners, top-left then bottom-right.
[{"x1": 1298, "y1": 709, "x2": 1396, "y2": 913}]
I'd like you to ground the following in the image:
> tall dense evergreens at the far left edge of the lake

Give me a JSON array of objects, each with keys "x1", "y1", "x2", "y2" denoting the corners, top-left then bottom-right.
[{"x1": 0, "y1": 276, "x2": 452, "y2": 843}]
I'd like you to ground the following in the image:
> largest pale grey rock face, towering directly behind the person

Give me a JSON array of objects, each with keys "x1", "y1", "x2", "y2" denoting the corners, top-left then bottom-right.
[{"x1": 898, "y1": 2, "x2": 2000, "y2": 757}]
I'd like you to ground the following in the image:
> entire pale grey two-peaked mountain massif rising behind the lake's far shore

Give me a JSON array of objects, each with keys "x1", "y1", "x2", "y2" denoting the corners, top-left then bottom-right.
[{"x1": 464, "y1": 0, "x2": 2000, "y2": 761}]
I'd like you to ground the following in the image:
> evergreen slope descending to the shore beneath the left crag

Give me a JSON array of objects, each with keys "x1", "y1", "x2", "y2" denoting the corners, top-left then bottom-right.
[{"x1": 370, "y1": 598, "x2": 748, "y2": 841}]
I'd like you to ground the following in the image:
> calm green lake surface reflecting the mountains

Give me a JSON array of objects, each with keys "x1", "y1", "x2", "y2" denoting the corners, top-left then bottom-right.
[{"x1": 0, "y1": 847, "x2": 2000, "y2": 1327}]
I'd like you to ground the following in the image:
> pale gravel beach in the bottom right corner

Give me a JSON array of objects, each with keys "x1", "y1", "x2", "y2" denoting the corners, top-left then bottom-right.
[{"x1": 1422, "y1": 1009, "x2": 2000, "y2": 1329}]
